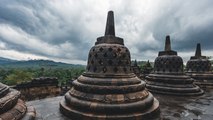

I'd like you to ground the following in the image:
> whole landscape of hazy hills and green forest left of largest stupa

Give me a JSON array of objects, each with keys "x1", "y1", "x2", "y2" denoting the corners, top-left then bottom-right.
[{"x1": 0, "y1": 58, "x2": 85, "y2": 85}]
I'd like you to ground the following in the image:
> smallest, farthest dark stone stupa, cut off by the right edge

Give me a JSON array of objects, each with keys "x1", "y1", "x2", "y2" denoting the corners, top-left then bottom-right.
[{"x1": 186, "y1": 43, "x2": 213, "y2": 87}]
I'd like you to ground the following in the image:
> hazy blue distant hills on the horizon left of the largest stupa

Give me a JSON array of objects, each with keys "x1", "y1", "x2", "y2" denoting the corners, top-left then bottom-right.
[{"x1": 0, "y1": 57, "x2": 84, "y2": 68}]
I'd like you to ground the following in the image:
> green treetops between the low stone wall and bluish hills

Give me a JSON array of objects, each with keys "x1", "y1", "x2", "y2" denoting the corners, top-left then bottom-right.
[{"x1": 0, "y1": 66, "x2": 85, "y2": 85}]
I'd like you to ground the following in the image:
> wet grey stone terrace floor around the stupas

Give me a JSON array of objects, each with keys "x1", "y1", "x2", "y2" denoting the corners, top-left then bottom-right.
[{"x1": 27, "y1": 89, "x2": 213, "y2": 120}]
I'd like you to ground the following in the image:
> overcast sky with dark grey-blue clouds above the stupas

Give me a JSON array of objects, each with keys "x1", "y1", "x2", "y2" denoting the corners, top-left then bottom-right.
[{"x1": 0, "y1": 0, "x2": 213, "y2": 64}]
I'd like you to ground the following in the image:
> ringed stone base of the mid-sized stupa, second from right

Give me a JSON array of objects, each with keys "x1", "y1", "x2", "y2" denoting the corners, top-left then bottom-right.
[{"x1": 146, "y1": 74, "x2": 204, "y2": 96}]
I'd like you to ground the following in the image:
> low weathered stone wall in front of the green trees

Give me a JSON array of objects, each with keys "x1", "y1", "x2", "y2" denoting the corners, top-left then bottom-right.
[{"x1": 13, "y1": 77, "x2": 61, "y2": 101}]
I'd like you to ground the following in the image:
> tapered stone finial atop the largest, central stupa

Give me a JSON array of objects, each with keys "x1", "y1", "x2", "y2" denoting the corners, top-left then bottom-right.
[{"x1": 105, "y1": 11, "x2": 115, "y2": 36}]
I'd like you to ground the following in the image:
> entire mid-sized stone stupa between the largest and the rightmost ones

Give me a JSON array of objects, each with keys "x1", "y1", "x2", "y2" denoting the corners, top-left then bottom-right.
[{"x1": 146, "y1": 36, "x2": 203, "y2": 96}]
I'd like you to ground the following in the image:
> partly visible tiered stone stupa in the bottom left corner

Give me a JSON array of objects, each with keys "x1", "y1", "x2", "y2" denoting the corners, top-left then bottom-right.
[{"x1": 0, "y1": 83, "x2": 36, "y2": 120}]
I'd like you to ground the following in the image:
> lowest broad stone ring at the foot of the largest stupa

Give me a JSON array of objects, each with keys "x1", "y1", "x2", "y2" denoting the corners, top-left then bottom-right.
[{"x1": 60, "y1": 98, "x2": 160, "y2": 120}]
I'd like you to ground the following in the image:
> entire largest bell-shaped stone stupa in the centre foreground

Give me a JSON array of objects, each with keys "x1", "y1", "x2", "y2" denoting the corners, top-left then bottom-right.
[{"x1": 60, "y1": 11, "x2": 159, "y2": 120}]
